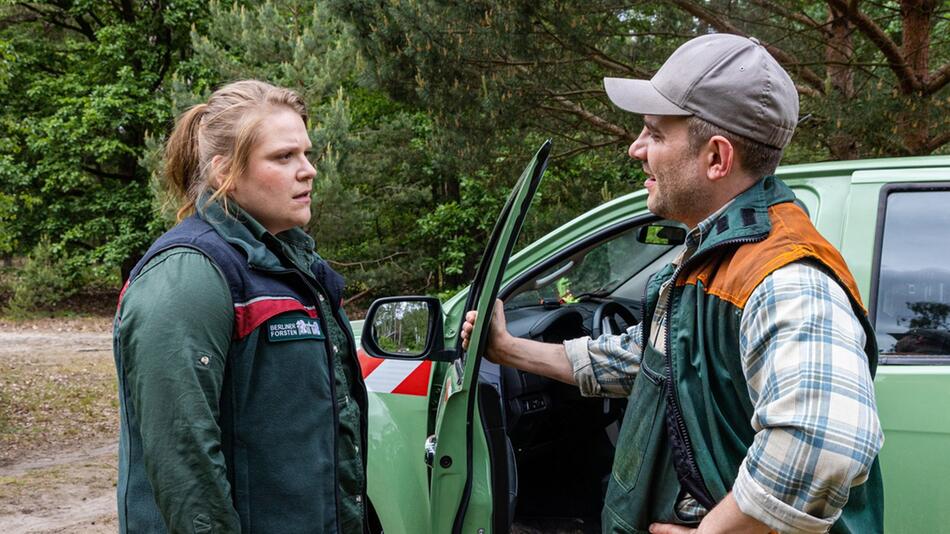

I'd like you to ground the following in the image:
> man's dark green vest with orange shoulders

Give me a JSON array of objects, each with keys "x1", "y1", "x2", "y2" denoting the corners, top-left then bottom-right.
[{"x1": 603, "y1": 177, "x2": 883, "y2": 534}]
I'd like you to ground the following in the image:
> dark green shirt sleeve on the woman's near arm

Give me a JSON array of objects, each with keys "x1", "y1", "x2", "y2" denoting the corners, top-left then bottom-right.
[{"x1": 119, "y1": 248, "x2": 241, "y2": 533}]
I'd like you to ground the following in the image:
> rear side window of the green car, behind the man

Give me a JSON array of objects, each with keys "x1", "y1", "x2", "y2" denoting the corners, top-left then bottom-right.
[{"x1": 874, "y1": 191, "x2": 950, "y2": 357}]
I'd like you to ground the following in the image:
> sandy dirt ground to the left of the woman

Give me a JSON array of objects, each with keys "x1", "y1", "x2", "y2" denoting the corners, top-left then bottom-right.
[{"x1": 0, "y1": 317, "x2": 118, "y2": 534}]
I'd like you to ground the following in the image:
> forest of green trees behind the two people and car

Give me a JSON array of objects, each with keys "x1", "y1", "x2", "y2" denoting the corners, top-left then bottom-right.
[{"x1": 0, "y1": 0, "x2": 950, "y2": 316}]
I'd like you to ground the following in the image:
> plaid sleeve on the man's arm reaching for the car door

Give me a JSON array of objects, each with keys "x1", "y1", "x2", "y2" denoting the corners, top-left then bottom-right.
[{"x1": 564, "y1": 324, "x2": 643, "y2": 397}]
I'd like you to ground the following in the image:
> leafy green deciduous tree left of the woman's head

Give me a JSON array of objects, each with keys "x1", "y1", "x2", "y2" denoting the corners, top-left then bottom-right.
[{"x1": 0, "y1": 0, "x2": 204, "y2": 310}]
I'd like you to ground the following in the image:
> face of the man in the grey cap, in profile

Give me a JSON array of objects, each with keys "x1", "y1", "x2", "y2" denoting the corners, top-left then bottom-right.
[{"x1": 628, "y1": 115, "x2": 709, "y2": 228}]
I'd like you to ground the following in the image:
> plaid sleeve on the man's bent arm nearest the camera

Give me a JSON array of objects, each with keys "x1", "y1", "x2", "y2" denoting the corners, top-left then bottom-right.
[{"x1": 733, "y1": 263, "x2": 884, "y2": 532}]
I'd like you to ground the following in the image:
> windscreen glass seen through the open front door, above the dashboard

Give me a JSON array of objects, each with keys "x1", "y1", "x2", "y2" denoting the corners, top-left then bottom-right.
[{"x1": 507, "y1": 223, "x2": 673, "y2": 307}]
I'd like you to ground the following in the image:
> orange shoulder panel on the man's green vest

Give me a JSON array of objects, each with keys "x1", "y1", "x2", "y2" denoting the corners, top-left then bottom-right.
[{"x1": 679, "y1": 202, "x2": 864, "y2": 309}]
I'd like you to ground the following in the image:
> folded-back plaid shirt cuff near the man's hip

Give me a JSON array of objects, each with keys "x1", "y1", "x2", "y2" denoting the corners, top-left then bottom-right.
[{"x1": 732, "y1": 460, "x2": 841, "y2": 534}]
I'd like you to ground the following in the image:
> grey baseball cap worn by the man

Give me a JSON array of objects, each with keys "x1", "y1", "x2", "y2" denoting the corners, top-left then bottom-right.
[{"x1": 604, "y1": 33, "x2": 798, "y2": 148}]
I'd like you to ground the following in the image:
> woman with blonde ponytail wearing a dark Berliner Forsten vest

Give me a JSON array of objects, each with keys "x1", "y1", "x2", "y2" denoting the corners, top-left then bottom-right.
[{"x1": 114, "y1": 80, "x2": 369, "y2": 533}]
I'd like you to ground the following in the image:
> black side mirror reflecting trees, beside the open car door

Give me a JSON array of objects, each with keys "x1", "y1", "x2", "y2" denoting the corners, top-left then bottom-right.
[{"x1": 360, "y1": 297, "x2": 456, "y2": 361}]
